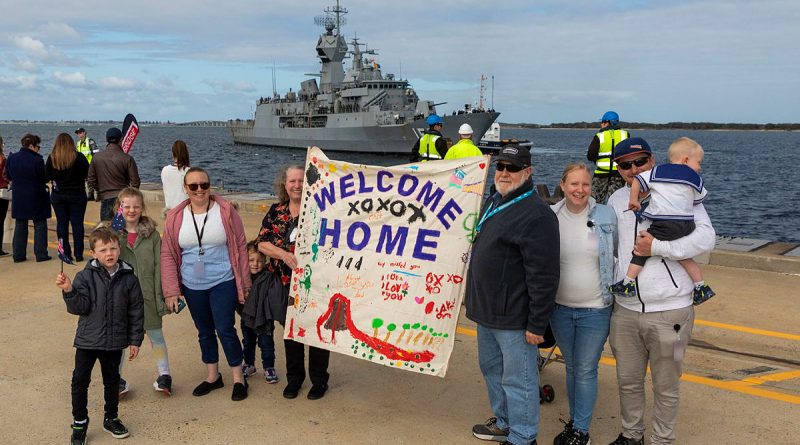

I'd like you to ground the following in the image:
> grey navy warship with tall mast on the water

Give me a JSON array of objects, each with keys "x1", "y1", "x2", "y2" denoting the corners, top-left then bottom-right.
[{"x1": 228, "y1": 0, "x2": 500, "y2": 153}]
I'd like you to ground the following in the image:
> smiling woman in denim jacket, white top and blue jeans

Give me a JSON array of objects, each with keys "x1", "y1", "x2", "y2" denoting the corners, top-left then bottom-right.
[{"x1": 550, "y1": 163, "x2": 617, "y2": 445}]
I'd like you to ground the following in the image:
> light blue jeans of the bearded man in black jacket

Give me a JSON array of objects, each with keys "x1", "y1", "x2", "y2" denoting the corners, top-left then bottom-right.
[{"x1": 478, "y1": 324, "x2": 539, "y2": 445}]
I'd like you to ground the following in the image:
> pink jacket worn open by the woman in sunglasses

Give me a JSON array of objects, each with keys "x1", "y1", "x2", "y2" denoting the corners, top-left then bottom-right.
[{"x1": 161, "y1": 195, "x2": 251, "y2": 301}]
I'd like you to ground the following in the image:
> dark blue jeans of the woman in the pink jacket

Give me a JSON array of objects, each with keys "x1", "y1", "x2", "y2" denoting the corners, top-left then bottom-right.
[{"x1": 181, "y1": 280, "x2": 242, "y2": 366}]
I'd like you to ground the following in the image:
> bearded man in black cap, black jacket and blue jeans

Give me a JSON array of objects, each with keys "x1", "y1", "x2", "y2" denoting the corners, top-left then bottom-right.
[{"x1": 466, "y1": 145, "x2": 560, "y2": 445}]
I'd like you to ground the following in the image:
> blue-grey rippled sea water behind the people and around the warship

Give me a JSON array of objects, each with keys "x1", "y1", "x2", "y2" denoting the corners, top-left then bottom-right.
[{"x1": 0, "y1": 125, "x2": 800, "y2": 242}]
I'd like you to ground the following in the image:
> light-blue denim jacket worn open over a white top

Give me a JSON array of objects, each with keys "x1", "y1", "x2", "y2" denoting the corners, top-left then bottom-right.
[{"x1": 550, "y1": 197, "x2": 617, "y2": 307}]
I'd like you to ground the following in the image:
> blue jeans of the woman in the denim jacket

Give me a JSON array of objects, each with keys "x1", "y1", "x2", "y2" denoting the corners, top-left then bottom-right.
[{"x1": 550, "y1": 304, "x2": 611, "y2": 433}]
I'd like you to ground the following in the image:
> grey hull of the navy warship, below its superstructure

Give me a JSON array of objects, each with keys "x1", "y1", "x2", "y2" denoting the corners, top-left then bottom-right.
[{"x1": 228, "y1": 112, "x2": 500, "y2": 153}]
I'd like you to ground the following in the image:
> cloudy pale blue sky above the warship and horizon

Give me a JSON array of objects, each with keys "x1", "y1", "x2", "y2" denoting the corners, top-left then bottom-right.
[{"x1": 0, "y1": 0, "x2": 800, "y2": 123}]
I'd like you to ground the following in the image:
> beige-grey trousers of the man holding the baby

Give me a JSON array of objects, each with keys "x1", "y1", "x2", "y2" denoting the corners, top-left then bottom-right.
[{"x1": 609, "y1": 304, "x2": 694, "y2": 444}]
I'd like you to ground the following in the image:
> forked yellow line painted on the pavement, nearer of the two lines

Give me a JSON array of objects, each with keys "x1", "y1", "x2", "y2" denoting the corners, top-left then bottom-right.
[{"x1": 456, "y1": 326, "x2": 800, "y2": 405}]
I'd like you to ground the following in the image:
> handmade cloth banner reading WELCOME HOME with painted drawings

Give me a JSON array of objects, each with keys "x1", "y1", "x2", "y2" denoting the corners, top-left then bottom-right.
[{"x1": 284, "y1": 147, "x2": 489, "y2": 377}]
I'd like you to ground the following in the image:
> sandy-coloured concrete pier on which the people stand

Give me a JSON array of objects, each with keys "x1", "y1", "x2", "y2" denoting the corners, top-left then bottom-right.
[{"x1": 0, "y1": 187, "x2": 800, "y2": 445}]
